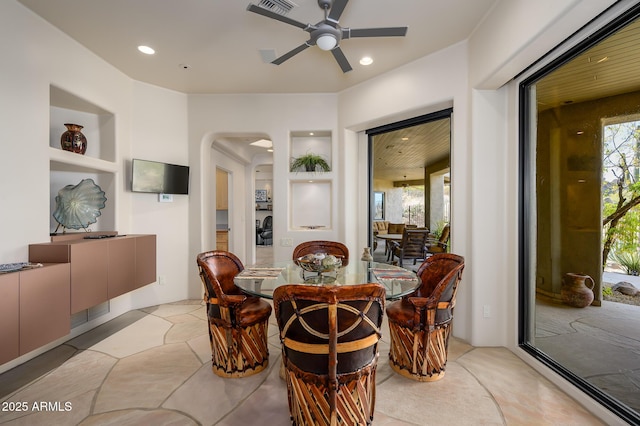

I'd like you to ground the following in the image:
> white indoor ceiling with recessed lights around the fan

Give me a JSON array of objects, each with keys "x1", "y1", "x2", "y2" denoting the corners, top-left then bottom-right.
[{"x1": 18, "y1": 0, "x2": 496, "y2": 94}]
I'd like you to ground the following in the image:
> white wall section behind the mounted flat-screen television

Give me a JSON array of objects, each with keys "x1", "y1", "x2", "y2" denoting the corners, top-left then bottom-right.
[{"x1": 129, "y1": 82, "x2": 190, "y2": 307}]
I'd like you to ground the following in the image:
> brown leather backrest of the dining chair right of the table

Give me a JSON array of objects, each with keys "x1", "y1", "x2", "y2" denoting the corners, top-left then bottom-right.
[{"x1": 410, "y1": 253, "x2": 464, "y2": 324}]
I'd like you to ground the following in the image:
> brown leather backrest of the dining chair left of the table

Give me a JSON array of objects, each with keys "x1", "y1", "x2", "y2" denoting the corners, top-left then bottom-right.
[{"x1": 197, "y1": 250, "x2": 244, "y2": 298}]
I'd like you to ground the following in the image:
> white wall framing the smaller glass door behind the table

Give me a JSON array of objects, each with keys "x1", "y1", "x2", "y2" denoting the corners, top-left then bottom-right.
[{"x1": 339, "y1": 43, "x2": 474, "y2": 341}]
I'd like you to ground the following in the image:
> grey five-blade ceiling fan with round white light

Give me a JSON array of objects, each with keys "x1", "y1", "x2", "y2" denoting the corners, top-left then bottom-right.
[{"x1": 247, "y1": 0, "x2": 407, "y2": 72}]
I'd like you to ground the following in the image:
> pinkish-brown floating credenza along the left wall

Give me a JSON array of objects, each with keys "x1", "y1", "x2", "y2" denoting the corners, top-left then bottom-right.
[{"x1": 0, "y1": 232, "x2": 156, "y2": 365}]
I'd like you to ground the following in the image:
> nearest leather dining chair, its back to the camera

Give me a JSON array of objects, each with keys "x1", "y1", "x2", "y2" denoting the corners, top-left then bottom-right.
[{"x1": 273, "y1": 284, "x2": 385, "y2": 425}]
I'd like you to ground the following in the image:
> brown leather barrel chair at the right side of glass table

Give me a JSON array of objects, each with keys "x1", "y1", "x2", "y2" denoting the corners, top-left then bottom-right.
[{"x1": 387, "y1": 253, "x2": 464, "y2": 382}]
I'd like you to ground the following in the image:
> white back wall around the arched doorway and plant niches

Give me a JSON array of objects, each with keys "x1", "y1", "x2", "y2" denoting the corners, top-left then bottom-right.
[{"x1": 188, "y1": 94, "x2": 341, "y2": 297}]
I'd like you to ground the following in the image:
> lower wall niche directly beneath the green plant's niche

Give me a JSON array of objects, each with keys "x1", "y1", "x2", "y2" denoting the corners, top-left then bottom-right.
[{"x1": 290, "y1": 180, "x2": 332, "y2": 230}]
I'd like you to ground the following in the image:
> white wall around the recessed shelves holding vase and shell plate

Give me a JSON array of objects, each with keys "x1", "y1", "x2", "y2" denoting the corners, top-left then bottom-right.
[{"x1": 0, "y1": 1, "x2": 132, "y2": 263}]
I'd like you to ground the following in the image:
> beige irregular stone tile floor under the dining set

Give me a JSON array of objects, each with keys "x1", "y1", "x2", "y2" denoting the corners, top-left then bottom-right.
[{"x1": 0, "y1": 300, "x2": 602, "y2": 426}]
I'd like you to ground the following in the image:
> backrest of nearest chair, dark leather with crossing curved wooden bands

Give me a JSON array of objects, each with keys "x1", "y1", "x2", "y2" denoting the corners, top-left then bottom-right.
[{"x1": 273, "y1": 283, "x2": 385, "y2": 413}]
